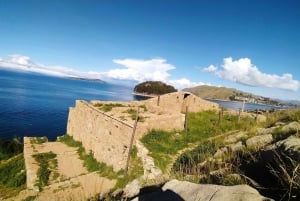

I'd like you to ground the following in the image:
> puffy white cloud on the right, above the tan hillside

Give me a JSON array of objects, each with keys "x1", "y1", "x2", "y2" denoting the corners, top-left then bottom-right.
[{"x1": 203, "y1": 57, "x2": 300, "y2": 91}]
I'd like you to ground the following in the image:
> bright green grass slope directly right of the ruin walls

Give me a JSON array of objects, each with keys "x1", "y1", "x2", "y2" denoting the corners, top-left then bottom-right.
[{"x1": 141, "y1": 111, "x2": 256, "y2": 171}]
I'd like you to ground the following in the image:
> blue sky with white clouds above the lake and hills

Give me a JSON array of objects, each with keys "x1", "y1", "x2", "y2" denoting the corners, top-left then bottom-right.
[{"x1": 0, "y1": 0, "x2": 300, "y2": 100}]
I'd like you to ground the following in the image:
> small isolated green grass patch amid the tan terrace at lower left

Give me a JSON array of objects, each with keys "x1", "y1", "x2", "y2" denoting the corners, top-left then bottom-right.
[{"x1": 33, "y1": 152, "x2": 57, "y2": 190}]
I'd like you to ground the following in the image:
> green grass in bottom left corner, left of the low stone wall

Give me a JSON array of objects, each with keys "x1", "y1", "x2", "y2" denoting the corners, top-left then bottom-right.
[{"x1": 0, "y1": 154, "x2": 26, "y2": 198}]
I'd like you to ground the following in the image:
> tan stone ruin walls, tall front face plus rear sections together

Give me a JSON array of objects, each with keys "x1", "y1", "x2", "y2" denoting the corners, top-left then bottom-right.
[{"x1": 67, "y1": 92, "x2": 218, "y2": 171}]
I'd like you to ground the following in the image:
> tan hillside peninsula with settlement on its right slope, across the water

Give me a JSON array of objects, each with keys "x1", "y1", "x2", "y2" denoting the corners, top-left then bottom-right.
[{"x1": 183, "y1": 85, "x2": 296, "y2": 106}]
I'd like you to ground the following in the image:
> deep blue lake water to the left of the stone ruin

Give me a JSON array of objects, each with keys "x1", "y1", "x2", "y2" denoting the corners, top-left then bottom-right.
[{"x1": 0, "y1": 70, "x2": 134, "y2": 140}]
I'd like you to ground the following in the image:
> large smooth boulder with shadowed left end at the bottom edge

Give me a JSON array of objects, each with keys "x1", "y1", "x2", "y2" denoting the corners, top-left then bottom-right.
[{"x1": 134, "y1": 180, "x2": 272, "y2": 201}]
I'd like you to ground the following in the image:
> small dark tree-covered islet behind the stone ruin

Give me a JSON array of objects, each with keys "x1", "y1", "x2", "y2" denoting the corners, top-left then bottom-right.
[{"x1": 133, "y1": 81, "x2": 177, "y2": 97}]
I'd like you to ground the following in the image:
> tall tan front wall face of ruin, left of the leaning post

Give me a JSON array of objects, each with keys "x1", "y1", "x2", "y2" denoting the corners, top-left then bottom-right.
[{"x1": 67, "y1": 100, "x2": 133, "y2": 171}]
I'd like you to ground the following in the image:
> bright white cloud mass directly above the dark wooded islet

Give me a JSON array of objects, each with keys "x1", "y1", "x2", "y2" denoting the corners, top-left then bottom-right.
[{"x1": 105, "y1": 58, "x2": 175, "y2": 82}]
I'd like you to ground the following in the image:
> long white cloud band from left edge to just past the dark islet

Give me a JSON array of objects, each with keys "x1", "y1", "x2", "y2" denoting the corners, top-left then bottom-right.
[{"x1": 0, "y1": 54, "x2": 204, "y2": 89}]
